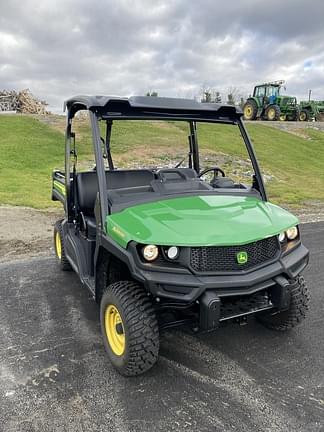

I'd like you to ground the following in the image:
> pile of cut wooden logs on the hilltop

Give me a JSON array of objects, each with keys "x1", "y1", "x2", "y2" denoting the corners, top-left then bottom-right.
[{"x1": 0, "y1": 89, "x2": 49, "y2": 115}]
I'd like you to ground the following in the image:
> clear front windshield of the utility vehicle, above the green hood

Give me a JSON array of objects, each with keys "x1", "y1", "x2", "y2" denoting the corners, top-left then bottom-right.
[{"x1": 70, "y1": 113, "x2": 266, "y2": 213}]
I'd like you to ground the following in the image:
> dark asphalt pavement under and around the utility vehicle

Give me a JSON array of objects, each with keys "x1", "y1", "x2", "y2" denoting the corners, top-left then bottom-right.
[{"x1": 0, "y1": 223, "x2": 324, "y2": 432}]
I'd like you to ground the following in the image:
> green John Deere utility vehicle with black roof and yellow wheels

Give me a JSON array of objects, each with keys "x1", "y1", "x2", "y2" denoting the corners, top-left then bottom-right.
[{"x1": 52, "y1": 96, "x2": 309, "y2": 376}]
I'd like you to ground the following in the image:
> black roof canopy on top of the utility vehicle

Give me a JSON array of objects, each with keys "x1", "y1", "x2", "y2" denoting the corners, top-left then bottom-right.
[{"x1": 64, "y1": 96, "x2": 242, "y2": 122}]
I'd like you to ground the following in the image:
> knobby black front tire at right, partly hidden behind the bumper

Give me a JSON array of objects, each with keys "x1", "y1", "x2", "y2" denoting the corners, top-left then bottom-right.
[{"x1": 257, "y1": 276, "x2": 310, "y2": 331}]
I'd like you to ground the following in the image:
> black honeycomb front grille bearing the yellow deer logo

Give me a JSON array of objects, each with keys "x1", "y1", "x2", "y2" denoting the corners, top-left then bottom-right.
[{"x1": 190, "y1": 236, "x2": 279, "y2": 272}]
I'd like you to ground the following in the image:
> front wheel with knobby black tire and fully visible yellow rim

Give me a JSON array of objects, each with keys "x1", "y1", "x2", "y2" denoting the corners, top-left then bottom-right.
[{"x1": 100, "y1": 281, "x2": 160, "y2": 376}]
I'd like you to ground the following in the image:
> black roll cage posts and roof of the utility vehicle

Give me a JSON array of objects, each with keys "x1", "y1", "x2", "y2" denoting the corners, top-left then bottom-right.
[{"x1": 64, "y1": 96, "x2": 267, "y2": 223}]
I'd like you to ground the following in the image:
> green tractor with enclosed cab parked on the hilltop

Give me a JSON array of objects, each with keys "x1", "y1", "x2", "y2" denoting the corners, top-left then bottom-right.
[{"x1": 243, "y1": 80, "x2": 299, "y2": 121}]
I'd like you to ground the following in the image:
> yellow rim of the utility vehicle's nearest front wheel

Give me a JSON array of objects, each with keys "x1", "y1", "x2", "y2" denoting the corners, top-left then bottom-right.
[{"x1": 105, "y1": 305, "x2": 125, "y2": 356}]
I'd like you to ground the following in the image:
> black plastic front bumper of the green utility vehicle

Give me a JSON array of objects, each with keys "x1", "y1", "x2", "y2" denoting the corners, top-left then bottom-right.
[{"x1": 102, "y1": 236, "x2": 309, "y2": 331}]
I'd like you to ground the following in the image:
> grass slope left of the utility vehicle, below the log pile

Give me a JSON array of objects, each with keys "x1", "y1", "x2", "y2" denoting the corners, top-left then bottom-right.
[{"x1": 0, "y1": 115, "x2": 64, "y2": 208}]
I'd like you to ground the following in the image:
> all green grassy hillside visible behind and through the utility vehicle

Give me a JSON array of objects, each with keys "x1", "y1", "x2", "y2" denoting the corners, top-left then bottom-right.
[{"x1": 0, "y1": 115, "x2": 324, "y2": 208}]
